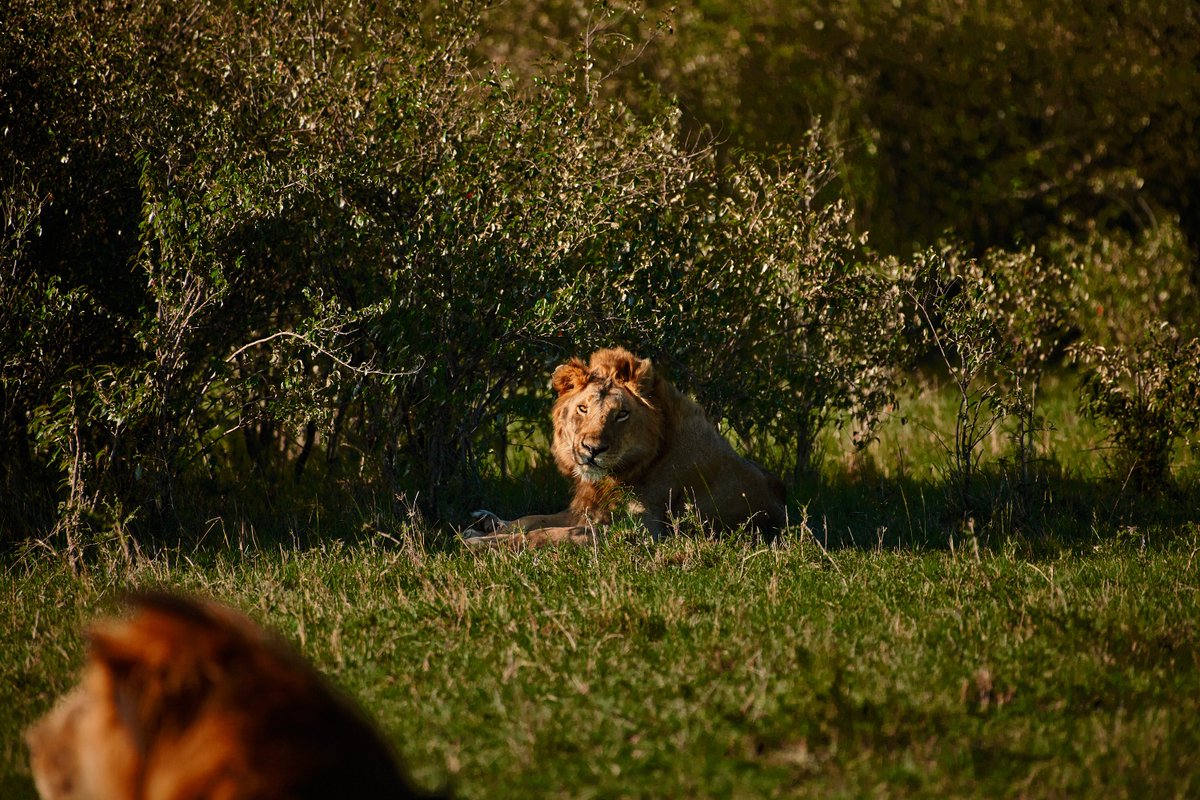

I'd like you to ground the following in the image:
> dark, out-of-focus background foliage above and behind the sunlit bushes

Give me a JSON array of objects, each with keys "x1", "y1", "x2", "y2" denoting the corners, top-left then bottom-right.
[{"x1": 480, "y1": 0, "x2": 1200, "y2": 253}]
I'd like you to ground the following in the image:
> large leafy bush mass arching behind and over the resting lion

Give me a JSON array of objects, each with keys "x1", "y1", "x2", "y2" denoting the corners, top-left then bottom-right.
[{"x1": 0, "y1": 0, "x2": 899, "y2": 544}]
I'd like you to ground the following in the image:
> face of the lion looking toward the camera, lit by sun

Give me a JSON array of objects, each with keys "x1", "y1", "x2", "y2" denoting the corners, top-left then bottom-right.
[{"x1": 553, "y1": 350, "x2": 662, "y2": 482}]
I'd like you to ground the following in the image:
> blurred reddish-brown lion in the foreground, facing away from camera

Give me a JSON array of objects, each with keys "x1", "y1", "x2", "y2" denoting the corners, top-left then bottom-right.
[{"x1": 26, "y1": 594, "x2": 441, "y2": 800}]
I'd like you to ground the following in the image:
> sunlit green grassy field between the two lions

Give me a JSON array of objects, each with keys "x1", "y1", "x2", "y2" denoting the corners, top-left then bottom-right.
[{"x1": 0, "y1": 376, "x2": 1200, "y2": 799}]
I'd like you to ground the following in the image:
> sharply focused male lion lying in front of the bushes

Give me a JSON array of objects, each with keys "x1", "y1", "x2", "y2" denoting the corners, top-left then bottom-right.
[{"x1": 463, "y1": 348, "x2": 787, "y2": 547}]
